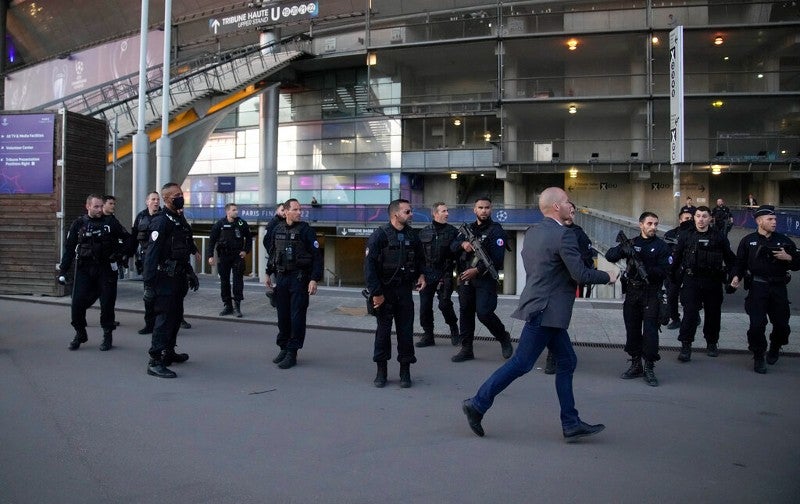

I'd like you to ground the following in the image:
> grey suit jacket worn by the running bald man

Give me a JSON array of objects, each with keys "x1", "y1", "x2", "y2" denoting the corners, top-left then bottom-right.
[{"x1": 511, "y1": 217, "x2": 610, "y2": 329}]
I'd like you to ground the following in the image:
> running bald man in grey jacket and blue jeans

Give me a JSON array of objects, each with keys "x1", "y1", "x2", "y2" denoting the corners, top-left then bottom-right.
[{"x1": 462, "y1": 187, "x2": 619, "y2": 443}]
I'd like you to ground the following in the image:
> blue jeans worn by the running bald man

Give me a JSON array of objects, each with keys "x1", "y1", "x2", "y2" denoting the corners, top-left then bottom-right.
[{"x1": 471, "y1": 313, "x2": 580, "y2": 429}]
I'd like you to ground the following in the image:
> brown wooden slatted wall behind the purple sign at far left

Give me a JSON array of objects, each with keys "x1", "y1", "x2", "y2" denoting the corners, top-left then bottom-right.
[{"x1": 0, "y1": 112, "x2": 107, "y2": 296}]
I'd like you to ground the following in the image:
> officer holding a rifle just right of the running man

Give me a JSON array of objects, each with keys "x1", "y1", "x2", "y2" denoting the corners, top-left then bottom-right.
[{"x1": 606, "y1": 212, "x2": 672, "y2": 387}]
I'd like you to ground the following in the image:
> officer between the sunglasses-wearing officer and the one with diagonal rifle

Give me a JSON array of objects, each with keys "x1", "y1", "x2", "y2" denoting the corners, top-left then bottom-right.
[{"x1": 417, "y1": 202, "x2": 459, "y2": 347}]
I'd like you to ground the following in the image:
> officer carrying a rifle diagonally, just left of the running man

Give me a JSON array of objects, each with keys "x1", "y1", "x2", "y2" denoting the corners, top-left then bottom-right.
[{"x1": 450, "y1": 197, "x2": 514, "y2": 362}]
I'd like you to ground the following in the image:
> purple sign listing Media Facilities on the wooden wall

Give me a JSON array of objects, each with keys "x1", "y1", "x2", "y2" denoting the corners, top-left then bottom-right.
[{"x1": 0, "y1": 114, "x2": 55, "y2": 194}]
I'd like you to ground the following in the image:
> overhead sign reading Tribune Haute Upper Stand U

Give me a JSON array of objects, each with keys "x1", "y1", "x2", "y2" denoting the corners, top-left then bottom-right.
[{"x1": 208, "y1": 0, "x2": 319, "y2": 35}]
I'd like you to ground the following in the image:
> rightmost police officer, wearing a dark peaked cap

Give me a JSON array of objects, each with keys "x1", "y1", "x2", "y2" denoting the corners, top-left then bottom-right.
[{"x1": 731, "y1": 205, "x2": 800, "y2": 374}]
